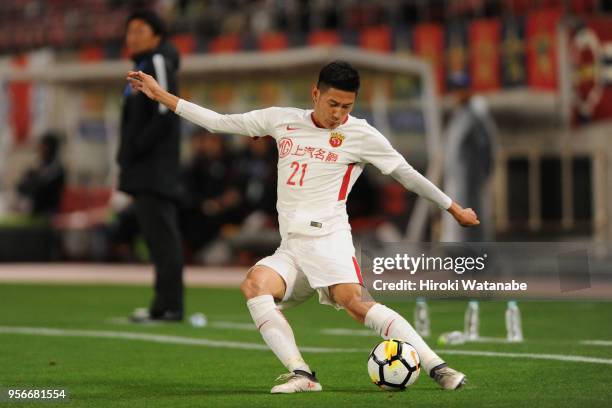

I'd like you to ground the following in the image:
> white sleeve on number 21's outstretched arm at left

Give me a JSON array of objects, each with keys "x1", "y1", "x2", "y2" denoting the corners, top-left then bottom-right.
[{"x1": 176, "y1": 99, "x2": 274, "y2": 137}]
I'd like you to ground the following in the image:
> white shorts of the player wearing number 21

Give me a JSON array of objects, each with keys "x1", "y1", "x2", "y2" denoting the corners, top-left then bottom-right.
[{"x1": 256, "y1": 230, "x2": 363, "y2": 309}]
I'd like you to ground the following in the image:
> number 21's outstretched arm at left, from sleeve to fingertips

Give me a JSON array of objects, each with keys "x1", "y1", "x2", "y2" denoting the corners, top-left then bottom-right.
[{"x1": 127, "y1": 71, "x2": 271, "y2": 136}]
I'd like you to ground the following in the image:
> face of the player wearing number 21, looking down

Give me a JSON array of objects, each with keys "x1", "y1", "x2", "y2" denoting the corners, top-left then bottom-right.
[{"x1": 312, "y1": 87, "x2": 357, "y2": 129}]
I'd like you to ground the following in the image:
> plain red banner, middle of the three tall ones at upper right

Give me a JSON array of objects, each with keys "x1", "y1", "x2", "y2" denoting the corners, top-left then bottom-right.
[{"x1": 470, "y1": 20, "x2": 501, "y2": 91}]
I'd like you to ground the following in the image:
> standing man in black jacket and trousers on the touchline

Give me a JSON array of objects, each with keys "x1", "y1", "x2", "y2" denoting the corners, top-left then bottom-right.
[{"x1": 117, "y1": 11, "x2": 183, "y2": 322}]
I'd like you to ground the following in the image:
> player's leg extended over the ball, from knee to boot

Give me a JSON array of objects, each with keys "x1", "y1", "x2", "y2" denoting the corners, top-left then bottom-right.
[{"x1": 329, "y1": 283, "x2": 465, "y2": 390}]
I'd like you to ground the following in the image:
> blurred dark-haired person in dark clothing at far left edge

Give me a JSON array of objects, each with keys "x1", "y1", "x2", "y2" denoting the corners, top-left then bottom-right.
[{"x1": 17, "y1": 132, "x2": 65, "y2": 216}]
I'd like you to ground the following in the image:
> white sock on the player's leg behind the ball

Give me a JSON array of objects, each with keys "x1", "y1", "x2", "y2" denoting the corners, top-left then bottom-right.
[{"x1": 365, "y1": 303, "x2": 444, "y2": 374}]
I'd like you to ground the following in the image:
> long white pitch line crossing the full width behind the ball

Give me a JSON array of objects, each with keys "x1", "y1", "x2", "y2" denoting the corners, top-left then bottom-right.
[{"x1": 0, "y1": 326, "x2": 612, "y2": 365}]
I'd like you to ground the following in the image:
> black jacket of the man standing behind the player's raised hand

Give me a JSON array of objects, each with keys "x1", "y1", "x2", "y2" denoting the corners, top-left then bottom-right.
[{"x1": 117, "y1": 42, "x2": 180, "y2": 198}]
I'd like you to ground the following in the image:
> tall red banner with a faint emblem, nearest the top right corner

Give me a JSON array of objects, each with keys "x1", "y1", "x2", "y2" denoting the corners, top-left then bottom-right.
[{"x1": 525, "y1": 9, "x2": 561, "y2": 90}]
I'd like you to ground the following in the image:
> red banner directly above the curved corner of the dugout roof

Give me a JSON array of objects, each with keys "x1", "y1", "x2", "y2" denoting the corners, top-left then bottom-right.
[{"x1": 412, "y1": 24, "x2": 446, "y2": 93}]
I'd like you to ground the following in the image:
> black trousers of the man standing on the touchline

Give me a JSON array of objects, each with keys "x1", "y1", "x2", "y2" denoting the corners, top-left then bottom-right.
[{"x1": 134, "y1": 194, "x2": 184, "y2": 315}]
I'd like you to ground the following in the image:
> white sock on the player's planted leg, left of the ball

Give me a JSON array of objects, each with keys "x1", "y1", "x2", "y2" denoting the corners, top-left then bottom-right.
[{"x1": 247, "y1": 295, "x2": 312, "y2": 373}]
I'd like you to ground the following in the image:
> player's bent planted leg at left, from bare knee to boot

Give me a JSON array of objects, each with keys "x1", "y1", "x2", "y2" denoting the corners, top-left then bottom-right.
[{"x1": 240, "y1": 265, "x2": 322, "y2": 394}]
